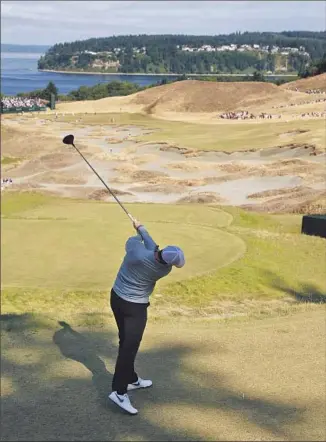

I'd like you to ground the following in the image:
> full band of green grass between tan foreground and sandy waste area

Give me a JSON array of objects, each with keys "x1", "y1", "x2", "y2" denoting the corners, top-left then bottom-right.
[{"x1": 2, "y1": 193, "x2": 326, "y2": 322}]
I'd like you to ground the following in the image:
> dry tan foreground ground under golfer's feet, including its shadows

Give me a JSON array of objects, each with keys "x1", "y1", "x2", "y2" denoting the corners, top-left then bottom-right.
[{"x1": 1, "y1": 307, "x2": 326, "y2": 441}]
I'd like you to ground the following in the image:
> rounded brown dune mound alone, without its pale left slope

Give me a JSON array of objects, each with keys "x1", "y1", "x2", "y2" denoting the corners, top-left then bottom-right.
[{"x1": 130, "y1": 80, "x2": 288, "y2": 114}]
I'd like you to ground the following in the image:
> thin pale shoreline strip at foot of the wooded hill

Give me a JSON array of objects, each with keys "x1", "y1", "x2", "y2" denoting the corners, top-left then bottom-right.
[{"x1": 38, "y1": 69, "x2": 296, "y2": 78}]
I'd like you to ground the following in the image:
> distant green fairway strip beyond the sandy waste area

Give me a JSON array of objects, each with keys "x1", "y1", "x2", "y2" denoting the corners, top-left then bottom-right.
[{"x1": 46, "y1": 113, "x2": 326, "y2": 152}]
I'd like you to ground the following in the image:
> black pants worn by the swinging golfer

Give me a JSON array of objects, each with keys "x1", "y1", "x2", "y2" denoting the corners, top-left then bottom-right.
[{"x1": 111, "y1": 289, "x2": 149, "y2": 394}]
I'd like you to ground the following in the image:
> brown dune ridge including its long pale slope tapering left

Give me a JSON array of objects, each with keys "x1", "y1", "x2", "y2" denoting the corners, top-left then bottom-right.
[{"x1": 58, "y1": 80, "x2": 293, "y2": 114}]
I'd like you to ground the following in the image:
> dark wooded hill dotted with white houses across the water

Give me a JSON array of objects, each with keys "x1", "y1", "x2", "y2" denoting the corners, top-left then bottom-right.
[{"x1": 38, "y1": 31, "x2": 326, "y2": 75}]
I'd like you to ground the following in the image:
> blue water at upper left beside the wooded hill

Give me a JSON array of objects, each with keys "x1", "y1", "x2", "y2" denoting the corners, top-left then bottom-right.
[{"x1": 1, "y1": 52, "x2": 178, "y2": 95}]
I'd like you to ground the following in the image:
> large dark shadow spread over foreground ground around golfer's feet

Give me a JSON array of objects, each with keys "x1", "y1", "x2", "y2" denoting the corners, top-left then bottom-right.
[{"x1": 1, "y1": 315, "x2": 310, "y2": 441}]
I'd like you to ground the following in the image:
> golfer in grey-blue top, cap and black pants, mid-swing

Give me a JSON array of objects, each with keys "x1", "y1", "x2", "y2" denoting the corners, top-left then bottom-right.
[{"x1": 109, "y1": 220, "x2": 185, "y2": 414}]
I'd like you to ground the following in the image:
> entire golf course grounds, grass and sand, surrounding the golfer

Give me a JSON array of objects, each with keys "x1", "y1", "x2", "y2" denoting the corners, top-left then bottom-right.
[{"x1": 1, "y1": 75, "x2": 326, "y2": 441}]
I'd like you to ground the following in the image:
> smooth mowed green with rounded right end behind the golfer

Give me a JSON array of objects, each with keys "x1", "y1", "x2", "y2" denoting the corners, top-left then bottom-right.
[{"x1": 2, "y1": 193, "x2": 245, "y2": 290}]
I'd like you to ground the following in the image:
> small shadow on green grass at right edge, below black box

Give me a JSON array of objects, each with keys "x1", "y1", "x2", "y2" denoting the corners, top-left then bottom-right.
[{"x1": 264, "y1": 271, "x2": 326, "y2": 304}]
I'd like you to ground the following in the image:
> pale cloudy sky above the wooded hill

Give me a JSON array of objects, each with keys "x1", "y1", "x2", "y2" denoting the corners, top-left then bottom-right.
[{"x1": 1, "y1": 0, "x2": 326, "y2": 45}]
